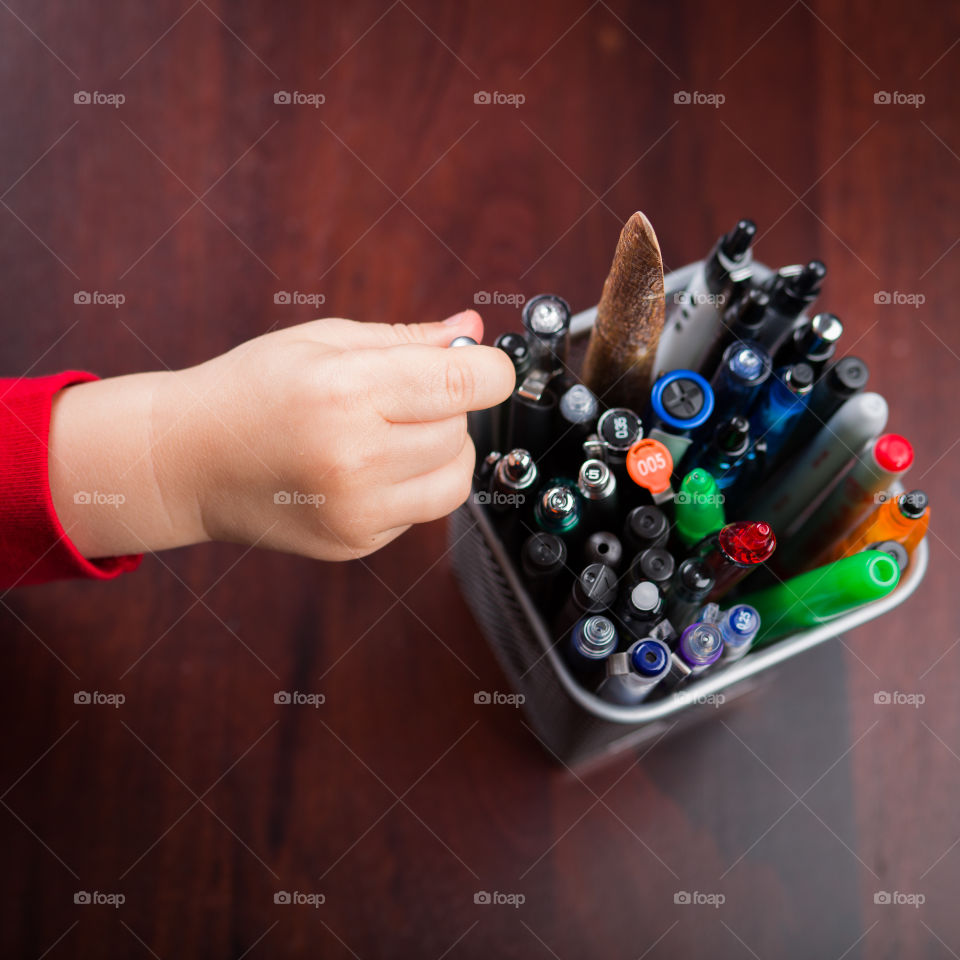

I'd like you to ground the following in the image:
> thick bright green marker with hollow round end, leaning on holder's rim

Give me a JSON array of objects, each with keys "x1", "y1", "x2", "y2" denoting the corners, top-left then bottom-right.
[{"x1": 738, "y1": 550, "x2": 900, "y2": 649}]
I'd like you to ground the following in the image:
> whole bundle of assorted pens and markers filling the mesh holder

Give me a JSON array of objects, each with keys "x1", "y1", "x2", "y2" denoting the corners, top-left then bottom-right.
[{"x1": 470, "y1": 212, "x2": 929, "y2": 704}]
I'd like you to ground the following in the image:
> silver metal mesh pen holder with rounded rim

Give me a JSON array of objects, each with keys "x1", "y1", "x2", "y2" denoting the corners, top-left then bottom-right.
[{"x1": 448, "y1": 264, "x2": 928, "y2": 767}]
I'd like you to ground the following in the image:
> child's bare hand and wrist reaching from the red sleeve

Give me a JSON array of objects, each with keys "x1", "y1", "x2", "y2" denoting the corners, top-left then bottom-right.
[{"x1": 50, "y1": 311, "x2": 515, "y2": 560}]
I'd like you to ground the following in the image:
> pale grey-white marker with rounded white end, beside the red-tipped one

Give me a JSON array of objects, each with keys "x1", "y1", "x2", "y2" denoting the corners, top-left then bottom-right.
[{"x1": 747, "y1": 393, "x2": 887, "y2": 537}]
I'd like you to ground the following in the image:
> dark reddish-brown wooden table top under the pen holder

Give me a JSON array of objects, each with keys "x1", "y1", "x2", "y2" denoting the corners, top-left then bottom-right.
[{"x1": 0, "y1": 0, "x2": 960, "y2": 960}]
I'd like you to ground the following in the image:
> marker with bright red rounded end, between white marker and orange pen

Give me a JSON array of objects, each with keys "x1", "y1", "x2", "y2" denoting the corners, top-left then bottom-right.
[{"x1": 774, "y1": 433, "x2": 913, "y2": 575}]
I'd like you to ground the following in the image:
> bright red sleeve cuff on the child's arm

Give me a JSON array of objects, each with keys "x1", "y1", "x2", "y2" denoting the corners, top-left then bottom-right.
[{"x1": 0, "y1": 370, "x2": 143, "y2": 590}]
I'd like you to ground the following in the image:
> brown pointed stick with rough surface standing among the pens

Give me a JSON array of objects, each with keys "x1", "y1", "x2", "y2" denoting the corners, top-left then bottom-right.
[{"x1": 581, "y1": 211, "x2": 665, "y2": 406}]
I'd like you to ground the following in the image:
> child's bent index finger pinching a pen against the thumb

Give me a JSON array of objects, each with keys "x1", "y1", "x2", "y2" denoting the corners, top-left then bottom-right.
[{"x1": 371, "y1": 344, "x2": 516, "y2": 423}]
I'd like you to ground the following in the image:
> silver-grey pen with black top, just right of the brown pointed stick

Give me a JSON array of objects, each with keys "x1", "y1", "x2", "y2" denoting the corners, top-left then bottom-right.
[{"x1": 657, "y1": 220, "x2": 757, "y2": 372}]
